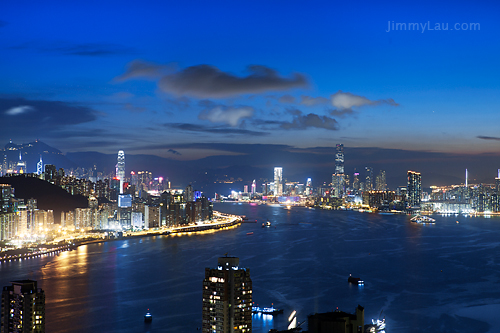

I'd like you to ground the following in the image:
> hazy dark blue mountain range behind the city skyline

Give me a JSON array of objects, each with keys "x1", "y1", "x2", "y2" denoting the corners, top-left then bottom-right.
[{"x1": 4, "y1": 141, "x2": 500, "y2": 196}]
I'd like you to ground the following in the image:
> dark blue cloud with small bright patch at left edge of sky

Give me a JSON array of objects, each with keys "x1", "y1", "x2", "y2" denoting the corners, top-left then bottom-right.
[{"x1": 0, "y1": 98, "x2": 97, "y2": 137}]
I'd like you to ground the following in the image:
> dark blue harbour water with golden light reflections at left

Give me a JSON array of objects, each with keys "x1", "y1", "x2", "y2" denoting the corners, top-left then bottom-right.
[{"x1": 0, "y1": 203, "x2": 500, "y2": 333}]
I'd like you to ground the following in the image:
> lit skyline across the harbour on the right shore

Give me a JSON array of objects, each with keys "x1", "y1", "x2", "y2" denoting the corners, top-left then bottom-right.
[{"x1": 234, "y1": 144, "x2": 500, "y2": 214}]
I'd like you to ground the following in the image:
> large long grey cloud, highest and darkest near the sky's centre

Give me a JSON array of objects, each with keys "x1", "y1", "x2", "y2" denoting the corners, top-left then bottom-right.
[{"x1": 116, "y1": 60, "x2": 308, "y2": 98}]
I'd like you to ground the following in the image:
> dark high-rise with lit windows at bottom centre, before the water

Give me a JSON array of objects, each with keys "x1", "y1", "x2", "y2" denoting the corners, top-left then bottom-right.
[{"x1": 202, "y1": 256, "x2": 252, "y2": 333}]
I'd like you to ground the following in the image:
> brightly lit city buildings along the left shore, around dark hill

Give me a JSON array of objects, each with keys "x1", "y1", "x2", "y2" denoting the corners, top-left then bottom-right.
[{"x1": 0, "y1": 151, "x2": 213, "y2": 241}]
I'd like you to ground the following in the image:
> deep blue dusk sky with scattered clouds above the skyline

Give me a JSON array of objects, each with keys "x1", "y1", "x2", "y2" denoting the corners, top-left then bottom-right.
[{"x1": 0, "y1": 1, "x2": 500, "y2": 182}]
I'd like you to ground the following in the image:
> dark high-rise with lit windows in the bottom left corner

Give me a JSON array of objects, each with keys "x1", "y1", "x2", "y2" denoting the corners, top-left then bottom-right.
[{"x1": 0, "y1": 280, "x2": 45, "y2": 333}]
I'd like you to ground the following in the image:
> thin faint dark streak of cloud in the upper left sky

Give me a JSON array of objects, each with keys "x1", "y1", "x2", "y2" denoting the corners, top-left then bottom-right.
[{"x1": 11, "y1": 42, "x2": 135, "y2": 57}]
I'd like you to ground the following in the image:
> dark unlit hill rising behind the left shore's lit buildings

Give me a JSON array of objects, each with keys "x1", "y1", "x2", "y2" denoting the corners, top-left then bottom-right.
[{"x1": 0, "y1": 175, "x2": 88, "y2": 223}]
